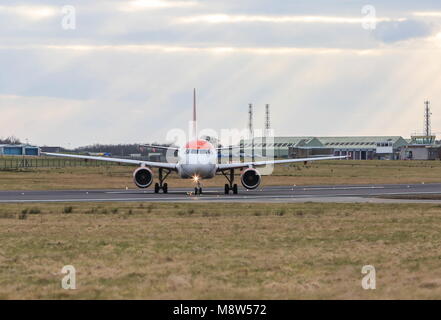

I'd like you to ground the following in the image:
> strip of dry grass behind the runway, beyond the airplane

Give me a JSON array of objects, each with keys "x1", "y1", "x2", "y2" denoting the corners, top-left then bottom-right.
[{"x1": 0, "y1": 160, "x2": 441, "y2": 190}]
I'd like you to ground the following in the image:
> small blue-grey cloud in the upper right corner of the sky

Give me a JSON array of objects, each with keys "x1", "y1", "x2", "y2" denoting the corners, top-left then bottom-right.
[{"x1": 373, "y1": 20, "x2": 433, "y2": 43}]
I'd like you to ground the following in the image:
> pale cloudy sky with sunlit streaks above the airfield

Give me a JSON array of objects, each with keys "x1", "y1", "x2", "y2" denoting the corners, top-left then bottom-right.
[{"x1": 0, "y1": 0, "x2": 441, "y2": 147}]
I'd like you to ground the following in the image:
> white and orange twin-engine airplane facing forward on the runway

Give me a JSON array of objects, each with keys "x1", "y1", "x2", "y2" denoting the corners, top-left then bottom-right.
[{"x1": 42, "y1": 90, "x2": 347, "y2": 195}]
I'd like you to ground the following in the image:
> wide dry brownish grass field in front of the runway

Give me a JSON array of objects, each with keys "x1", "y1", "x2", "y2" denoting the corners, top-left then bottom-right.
[{"x1": 0, "y1": 203, "x2": 441, "y2": 299}]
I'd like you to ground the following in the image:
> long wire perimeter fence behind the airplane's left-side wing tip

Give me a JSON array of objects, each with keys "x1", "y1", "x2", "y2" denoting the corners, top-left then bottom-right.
[{"x1": 0, "y1": 156, "x2": 123, "y2": 171}]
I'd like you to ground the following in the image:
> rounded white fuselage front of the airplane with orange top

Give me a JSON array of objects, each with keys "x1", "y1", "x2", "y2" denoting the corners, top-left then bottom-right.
[{"x1": 177, "y1": 140, "x2": 217, "y2": 179}]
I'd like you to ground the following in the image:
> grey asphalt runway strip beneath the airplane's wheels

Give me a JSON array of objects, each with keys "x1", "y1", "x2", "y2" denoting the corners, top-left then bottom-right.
[{"x1": 0, "y1": 183, "x2": 441, "y2": 203}]
